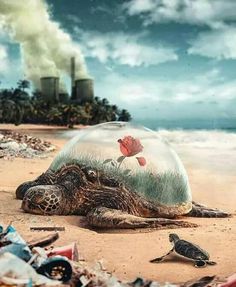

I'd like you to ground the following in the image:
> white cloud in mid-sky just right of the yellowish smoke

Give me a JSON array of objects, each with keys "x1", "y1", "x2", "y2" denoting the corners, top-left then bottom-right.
[{"x1": 75, "y1": 28, "x2": 178, "y2": 67}]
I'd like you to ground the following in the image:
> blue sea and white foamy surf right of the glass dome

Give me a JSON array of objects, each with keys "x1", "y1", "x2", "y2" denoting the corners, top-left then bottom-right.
[{"x1": 134, "y1": 118, "x2": 236, "y2": 154}]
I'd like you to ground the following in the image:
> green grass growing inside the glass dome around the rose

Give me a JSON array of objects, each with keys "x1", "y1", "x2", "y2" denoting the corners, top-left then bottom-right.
[{"x1": 50, "y1": 155, "x2": 191, "y2": 205}]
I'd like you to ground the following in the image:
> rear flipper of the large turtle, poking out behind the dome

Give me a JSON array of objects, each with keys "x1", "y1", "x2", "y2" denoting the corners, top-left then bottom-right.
[{"x1": 187, "y1": 201, "x2": 231, "y2": 218}]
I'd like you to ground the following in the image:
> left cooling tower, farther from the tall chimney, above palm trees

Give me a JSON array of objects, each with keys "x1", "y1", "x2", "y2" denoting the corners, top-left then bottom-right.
[{"x1": 40, "y1": 77, "x2": 59, "y2": 103}]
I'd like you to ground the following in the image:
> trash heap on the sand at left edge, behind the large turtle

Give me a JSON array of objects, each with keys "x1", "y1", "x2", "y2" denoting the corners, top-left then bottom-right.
[{"x1": 0, "y1": 131, "x2": 55, "y2": 159}]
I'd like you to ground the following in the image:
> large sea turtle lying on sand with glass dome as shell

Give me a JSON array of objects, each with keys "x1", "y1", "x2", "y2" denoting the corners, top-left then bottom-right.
[{"x1": 16, "y1": 123, "x2": 229, "y2": 231}]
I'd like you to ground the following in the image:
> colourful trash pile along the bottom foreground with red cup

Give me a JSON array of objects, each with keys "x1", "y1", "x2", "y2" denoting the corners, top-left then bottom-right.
[{"x1": 0, "y1": 225, "x2": 236, "y2": 287}]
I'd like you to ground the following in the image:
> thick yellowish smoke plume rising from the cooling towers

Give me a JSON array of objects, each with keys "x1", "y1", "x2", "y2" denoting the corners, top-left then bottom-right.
[{"x1": 0, "y1": 0, "x2": 87, "y2": 88}]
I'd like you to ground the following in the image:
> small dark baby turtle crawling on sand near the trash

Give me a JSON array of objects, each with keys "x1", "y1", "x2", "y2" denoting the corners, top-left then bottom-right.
[{"x1": 150, "y1": 233, "x2": 216, "y2": 267}]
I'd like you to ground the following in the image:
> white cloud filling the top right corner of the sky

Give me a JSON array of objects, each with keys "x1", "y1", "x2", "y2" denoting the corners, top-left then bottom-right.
[{"x1": 122, "y1": 0, "x2": 236, "y2": 60}]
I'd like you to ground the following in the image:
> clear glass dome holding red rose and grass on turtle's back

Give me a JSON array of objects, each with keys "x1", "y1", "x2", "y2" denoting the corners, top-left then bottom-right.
[{"x1": 50, "y1": 122, "x2": 192, "y2": 209}]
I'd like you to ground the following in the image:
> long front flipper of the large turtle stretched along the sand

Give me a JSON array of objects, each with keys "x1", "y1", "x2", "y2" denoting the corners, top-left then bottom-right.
[{"x1": 87, "y1": 207, "x2": 196, "y2": 229}]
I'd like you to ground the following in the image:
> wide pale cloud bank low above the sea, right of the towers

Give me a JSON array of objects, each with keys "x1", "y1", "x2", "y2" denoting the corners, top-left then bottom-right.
[{"x1": 96, "y1": 69, "x2": 236, "y2": 118}]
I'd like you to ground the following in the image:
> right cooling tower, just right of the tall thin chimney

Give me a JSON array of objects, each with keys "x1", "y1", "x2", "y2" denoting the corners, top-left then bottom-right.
[{"x1": 72, "y1": 79, "x2": 93, "y2": 104}]
